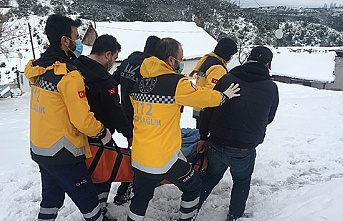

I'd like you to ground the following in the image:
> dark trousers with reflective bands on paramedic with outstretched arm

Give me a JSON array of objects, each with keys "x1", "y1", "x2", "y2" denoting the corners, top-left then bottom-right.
[{"x1": 127, "y1": 159, "x2": 201, "y2": 221}]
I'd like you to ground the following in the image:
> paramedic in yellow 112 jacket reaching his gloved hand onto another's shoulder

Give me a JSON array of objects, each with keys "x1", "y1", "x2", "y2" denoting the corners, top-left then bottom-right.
[{"x1": 127, "y1": 38, "x2": 239, "y2": 221}]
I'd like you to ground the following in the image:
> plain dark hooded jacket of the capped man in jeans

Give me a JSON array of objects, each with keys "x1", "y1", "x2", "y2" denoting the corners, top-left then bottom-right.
[{"x1": 200, "y1": 61, "x2": 279, "y2": 149}]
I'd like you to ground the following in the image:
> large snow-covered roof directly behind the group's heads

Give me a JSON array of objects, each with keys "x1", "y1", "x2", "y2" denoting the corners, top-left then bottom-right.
[{"x1": 83, "y1": 21, "x2": 217, "y2": 61}]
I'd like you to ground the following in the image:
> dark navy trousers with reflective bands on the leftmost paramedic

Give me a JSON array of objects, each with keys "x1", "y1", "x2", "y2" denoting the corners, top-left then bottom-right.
[{"x1": 38, "y1": 162, "x2": 102, "y2": 221}]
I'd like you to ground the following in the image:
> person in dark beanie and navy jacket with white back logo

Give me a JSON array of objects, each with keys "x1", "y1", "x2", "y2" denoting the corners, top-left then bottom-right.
[{"x1": 113, "y1": 35, "x2": 160, "y2": 205}]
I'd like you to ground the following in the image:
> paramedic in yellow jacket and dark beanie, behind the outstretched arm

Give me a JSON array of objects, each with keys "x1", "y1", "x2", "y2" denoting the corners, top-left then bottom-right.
[{"x1": 189, "y1": 38, "x2": 237, "y2": 128}]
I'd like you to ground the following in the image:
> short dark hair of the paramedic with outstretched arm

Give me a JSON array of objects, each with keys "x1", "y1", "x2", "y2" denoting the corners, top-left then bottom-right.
[{"x1": 155, "y1": 38, "x2": 181, "y2": 62}]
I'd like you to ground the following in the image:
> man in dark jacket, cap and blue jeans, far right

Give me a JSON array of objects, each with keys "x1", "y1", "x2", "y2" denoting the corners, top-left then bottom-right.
[{"x1": 199, "y1": 46, "x2": 279, "y2": 221}]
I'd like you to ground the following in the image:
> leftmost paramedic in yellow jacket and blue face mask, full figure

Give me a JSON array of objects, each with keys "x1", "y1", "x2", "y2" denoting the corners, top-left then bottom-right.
[{"x1": 24, "y1": 14, "x2": 111, "y2": 221}]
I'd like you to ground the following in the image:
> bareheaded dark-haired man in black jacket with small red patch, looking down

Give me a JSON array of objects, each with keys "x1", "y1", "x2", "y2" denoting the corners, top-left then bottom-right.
[{"x1": 74, "y1": 34, "x2": 132, "y2": 218}]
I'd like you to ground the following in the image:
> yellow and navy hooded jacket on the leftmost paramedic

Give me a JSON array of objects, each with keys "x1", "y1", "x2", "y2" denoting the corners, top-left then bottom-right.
[{"x1": 24, "y1": 47, "x2": 106, "y2": 164}]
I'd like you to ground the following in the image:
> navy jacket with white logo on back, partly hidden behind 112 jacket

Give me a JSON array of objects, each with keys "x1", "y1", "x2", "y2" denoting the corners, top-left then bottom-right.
[{"x1": 113, "y1": 51, "x2": 150, "y2": 124}]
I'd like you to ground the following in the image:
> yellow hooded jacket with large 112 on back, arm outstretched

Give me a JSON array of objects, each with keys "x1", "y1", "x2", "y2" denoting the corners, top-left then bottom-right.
[{"x1": 131, "y1": 56, "x2": 228, "y2": 174}]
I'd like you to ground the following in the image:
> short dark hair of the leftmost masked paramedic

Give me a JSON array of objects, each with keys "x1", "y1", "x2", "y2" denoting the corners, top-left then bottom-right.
[{"x1": 45, "y1": 14, "x2": 81, "y2": 48}]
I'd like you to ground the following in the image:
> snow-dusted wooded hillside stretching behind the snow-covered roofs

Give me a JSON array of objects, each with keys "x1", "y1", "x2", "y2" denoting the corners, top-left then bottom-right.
[{"x1": 0, "y1": 0, "x2": 343, "y2": 46}]
